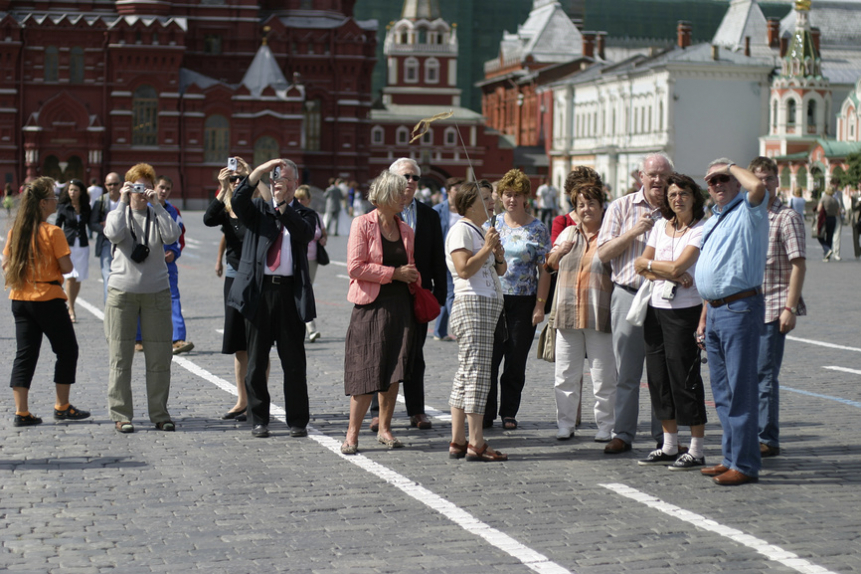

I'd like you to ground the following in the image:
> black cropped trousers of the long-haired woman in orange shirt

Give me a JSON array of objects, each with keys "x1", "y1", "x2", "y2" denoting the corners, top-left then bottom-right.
[{"x1": 9, "y1": 299, "x2": 78, "y2": 389}]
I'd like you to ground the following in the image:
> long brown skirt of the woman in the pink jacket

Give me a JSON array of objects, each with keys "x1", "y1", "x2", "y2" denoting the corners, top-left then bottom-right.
[{"x1": 344, "y1": 284, "x2": 415, "y2": 396}]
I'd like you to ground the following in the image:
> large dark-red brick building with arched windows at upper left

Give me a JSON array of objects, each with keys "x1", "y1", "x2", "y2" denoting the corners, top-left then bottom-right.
[{"x1": 0, "y1": 0, "x2": 376, "y2": 207}]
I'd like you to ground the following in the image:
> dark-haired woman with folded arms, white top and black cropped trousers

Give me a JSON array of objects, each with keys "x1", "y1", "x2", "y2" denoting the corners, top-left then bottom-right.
[{"x1": 634, "y1": 173, "x2": 706, "y2": 470}]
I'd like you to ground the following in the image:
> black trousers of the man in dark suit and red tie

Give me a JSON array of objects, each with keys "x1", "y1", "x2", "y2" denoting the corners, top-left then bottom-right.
[{"x1": 245, "y1": 277, "x2": 310, "y2": 428}]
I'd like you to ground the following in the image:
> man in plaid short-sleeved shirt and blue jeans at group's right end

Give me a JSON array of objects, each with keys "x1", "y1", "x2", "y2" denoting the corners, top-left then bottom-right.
[{"x1": 748, "y1": 157, "x2": 806, "y2": 457}]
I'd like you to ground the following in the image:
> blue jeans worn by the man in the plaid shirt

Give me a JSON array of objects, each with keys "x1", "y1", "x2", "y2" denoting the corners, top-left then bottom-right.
[{"x1": 758, "y1": 320, "x2": 786, "y2": 447}]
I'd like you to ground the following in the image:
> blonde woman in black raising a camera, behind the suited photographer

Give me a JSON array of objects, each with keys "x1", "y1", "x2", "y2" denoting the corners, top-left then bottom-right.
[{"x1": 203, "y1": 157, "x2": 271, "y2": 422}]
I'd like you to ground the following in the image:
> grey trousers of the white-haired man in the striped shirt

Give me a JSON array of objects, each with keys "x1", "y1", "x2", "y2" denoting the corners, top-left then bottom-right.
[{"x1": 610, "y1": 285, "x2": 664, "y2": 444}]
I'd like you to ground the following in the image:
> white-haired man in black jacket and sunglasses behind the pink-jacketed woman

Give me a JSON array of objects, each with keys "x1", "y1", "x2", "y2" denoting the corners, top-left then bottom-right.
[{"x1": 371, "y1": 157, "x2": 448, "y2": 432}]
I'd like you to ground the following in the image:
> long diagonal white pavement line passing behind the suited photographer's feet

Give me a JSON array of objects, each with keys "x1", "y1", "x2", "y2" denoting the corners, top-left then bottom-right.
[{"x1": 82, "y1": 298, "x2": 573, "y2": 574}]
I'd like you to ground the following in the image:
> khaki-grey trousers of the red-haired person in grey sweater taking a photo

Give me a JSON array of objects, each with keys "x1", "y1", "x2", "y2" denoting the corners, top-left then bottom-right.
[{"x1": 105, "y1": 287, "x2": 173, "y2": 423}]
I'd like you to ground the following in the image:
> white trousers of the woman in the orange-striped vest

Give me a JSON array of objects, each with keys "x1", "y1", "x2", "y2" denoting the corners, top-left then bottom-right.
[{"x1": 555, "y1": 329, "x2": 616, "y2": 434}]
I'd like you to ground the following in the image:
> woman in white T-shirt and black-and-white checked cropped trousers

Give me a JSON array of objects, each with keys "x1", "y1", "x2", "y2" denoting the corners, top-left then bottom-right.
[{"x1": 445, "y1": 180, "x2": 508, "y2": 462}]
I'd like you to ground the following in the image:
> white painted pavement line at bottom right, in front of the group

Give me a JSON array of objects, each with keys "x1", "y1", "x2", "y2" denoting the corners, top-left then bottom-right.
[{"x1": 601, "y1": 483, "x2": 835, "y2": 574}]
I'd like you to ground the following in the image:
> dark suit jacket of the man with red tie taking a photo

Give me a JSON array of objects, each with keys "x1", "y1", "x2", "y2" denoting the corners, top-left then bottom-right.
[{"x1": 227, "y1": 177, "x2": 318, "y2": 322}]
